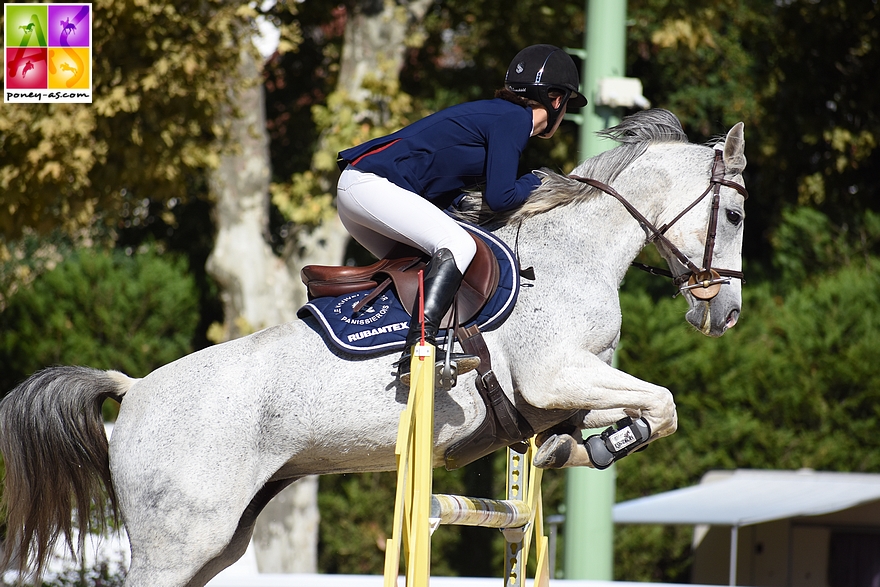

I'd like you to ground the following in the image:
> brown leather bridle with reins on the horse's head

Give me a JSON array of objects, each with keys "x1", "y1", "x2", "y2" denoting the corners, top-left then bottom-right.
[{"x1": 568, "y1": 149, "x2": 749, "y2": 301}]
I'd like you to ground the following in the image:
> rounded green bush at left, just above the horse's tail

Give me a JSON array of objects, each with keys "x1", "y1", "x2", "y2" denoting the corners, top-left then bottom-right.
[{"x1": 0, "y1": 249, "x2": 198, "y2": 392}]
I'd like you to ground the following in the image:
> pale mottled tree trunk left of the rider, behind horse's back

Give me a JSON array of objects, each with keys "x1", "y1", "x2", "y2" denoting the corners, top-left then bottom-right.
[{"x1": 208, "y1": 44, "x2": 324, "y2": 573}]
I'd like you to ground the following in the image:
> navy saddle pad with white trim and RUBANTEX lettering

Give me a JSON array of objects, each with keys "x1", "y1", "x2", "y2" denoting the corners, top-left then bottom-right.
[{"x1": 297, "y1": 222, "x2": 520, "y2": 355}]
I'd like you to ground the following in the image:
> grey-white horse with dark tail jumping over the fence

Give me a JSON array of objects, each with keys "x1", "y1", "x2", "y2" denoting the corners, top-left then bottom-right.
[{"x1": 0, "y1": 110, "x2": 745, "y2": 587}]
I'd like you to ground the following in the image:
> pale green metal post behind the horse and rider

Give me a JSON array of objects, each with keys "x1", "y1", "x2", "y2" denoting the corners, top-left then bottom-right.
[{"x1": 563, "y1": 0, "x2": 626, "y2": 581}]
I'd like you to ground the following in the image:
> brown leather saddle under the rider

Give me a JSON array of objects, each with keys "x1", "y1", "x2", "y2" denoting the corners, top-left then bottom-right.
[{"x1": 300, "y1": 235, "x2": 500, "y2": 328}]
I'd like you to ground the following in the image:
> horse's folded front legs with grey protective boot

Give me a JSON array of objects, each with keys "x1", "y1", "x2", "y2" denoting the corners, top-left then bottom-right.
[{"x1": 521, "y1": 355, "x2": 678, "y2": 468}]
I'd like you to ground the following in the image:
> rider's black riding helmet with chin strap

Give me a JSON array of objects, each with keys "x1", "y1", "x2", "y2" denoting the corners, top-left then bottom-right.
[{"x1": 504, "y1": 45, "x2": 587, "y2": 134}]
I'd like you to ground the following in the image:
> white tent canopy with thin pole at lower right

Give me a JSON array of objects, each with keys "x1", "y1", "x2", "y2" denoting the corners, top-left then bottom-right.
[{"x1": 613, "y1": 469, "x2": 880, "y2": 585}]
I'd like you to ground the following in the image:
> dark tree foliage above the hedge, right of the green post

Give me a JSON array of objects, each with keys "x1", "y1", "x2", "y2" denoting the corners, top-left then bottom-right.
[{"x1": 627, "y1": 0, "x2": 880, "y2": 266}]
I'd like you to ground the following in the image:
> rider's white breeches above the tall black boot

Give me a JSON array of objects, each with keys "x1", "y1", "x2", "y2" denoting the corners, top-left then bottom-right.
[{"x1": 336, "y1": 165, "x2": 477, "y2": 273}]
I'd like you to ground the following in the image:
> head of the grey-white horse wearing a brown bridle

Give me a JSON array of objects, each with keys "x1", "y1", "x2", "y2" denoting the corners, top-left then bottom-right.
[{"x1": 656, "y1": 122, "x2": 748, "y2": 336}]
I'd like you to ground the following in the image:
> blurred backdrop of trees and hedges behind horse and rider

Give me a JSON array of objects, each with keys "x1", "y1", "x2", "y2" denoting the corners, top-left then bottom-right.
[{"x1": 0, "y1": 0, "x2": 880, "y2": 582}]
